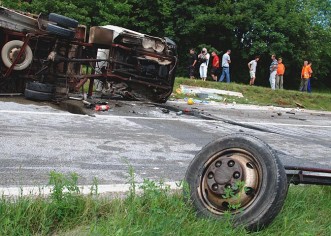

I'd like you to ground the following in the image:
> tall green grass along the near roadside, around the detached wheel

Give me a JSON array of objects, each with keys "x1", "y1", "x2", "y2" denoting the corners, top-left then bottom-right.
[{"x1": 0, "y1": 172, "x2": 331, "y2": 236}]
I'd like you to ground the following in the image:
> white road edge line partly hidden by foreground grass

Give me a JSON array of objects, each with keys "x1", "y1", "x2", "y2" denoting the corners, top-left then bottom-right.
[{"x1": 0, "y1": 181, "x2": 182, "y2": 197}]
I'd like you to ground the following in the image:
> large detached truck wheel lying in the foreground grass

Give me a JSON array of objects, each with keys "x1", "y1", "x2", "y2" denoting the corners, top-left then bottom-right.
[{"x1": 184, "y1": 134, "x2": 288, "y2": 231}]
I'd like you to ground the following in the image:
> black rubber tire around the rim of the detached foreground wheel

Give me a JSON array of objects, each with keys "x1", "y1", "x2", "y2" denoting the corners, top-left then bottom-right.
[{"x1": 184, "y1": 133, "x2": 288, "y2": 231}]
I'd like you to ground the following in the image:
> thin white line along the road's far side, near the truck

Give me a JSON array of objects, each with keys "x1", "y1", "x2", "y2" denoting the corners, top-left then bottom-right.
[{"x1": 0, "y1": 110, "x2": 331, "y2": 128}]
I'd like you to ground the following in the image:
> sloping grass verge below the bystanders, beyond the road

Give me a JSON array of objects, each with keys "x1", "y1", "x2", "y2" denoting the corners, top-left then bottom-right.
[{"x1": 173, "y1": 77, "x2": 331, "y2": 111}]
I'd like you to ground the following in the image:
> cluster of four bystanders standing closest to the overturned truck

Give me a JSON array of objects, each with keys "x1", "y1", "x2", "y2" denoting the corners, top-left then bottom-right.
[{"x1": 188, "y1": 48, "x2": 231, "y2": 83}]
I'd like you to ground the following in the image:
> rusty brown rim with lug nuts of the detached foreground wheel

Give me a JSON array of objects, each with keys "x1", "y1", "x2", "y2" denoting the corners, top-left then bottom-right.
[{"x1": 198, "y1": 148, "x2": 262, "y2": 215}]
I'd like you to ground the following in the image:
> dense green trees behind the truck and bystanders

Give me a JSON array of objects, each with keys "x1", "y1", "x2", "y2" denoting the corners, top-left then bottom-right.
[{"x1": 1, "y1": 0, "x2": 331, "y2": 88}]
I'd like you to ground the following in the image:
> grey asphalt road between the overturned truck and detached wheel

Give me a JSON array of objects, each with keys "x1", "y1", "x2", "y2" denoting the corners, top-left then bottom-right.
[{"x1": 0, "y1": 99, "x2": 331, "y2": 187}]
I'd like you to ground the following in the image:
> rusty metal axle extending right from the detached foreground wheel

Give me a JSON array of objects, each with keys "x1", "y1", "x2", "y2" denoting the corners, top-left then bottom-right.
[{"x1": 284, "y1": 166, "x2": 331, "y2": 185}]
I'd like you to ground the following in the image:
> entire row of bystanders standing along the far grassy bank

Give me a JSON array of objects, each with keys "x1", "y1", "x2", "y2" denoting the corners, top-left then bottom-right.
[{"x1": 189, "y1": 48, "x2": 313, "y2": 92}]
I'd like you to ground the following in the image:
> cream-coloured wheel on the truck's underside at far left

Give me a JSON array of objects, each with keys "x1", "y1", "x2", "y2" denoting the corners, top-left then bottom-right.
[{"x1": 1, "y1": 40, "x2": 33, "y2": 70}]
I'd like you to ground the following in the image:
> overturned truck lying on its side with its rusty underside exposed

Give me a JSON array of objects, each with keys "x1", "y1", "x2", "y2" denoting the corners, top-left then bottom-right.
[{"x1": 0, "y1": 7, "x2": 178, "y2": 103}]
